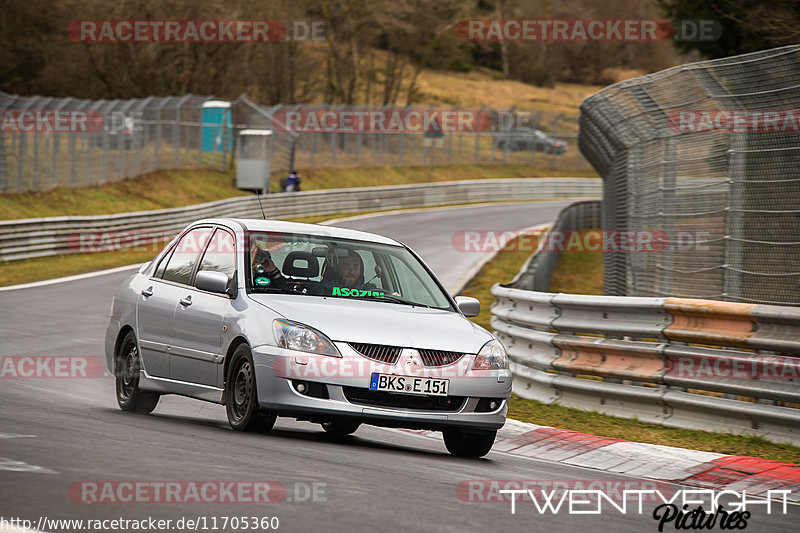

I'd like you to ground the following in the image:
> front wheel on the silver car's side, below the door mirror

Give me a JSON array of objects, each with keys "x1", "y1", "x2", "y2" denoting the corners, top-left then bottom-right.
[{"x1": 225, "y1": 344, "x2": 277, "y2": 433}]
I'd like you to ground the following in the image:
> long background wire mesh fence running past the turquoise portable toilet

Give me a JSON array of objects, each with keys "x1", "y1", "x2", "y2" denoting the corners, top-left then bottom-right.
[{"x1": 0, "y1": 92, "x2": 589, "y2": 193}]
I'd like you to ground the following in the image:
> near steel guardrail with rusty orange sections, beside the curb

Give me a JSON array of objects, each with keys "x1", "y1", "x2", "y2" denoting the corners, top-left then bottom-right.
[{"x1": 492, "y1": 284, "x2": 800, "y2": 445}]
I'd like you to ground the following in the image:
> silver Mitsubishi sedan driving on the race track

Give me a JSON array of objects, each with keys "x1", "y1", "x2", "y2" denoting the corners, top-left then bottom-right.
[{"x1": 106, "y1": 219, "x2": 511, "y2": 457}]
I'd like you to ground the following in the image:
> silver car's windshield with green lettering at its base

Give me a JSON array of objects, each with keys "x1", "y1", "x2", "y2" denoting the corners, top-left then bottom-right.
[{"x1": 246, "y1": 232, "x2": 452, "y2": 309}]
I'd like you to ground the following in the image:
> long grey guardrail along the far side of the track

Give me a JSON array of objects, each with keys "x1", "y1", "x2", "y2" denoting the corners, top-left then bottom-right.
[{"x1": 0, "y1": 178, "x2": 601, "y2": 261}]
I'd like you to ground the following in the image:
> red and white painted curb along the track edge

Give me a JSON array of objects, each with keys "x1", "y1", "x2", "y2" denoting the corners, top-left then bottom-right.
[{"x1": 415, "y1": 419, "x2": 800, "y2": 503}]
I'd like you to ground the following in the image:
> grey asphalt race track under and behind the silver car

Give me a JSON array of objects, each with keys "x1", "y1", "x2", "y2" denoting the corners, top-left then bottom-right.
[{"x1": 0, "y1": 202, "x2": 800, "y2": 533}]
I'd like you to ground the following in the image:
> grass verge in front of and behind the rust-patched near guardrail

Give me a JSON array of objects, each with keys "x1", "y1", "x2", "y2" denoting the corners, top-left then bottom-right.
[{"x1": 461, "y1": 233, "x2": 800, "y2": 463}]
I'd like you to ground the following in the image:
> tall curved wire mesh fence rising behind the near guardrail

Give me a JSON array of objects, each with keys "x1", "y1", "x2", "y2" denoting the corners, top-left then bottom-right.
[{"x1": 578, "y1": 46, "x2": 800, "y2": 305}]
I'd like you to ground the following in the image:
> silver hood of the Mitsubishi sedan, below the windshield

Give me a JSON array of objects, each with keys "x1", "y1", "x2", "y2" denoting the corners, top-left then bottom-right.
[{"x1": 248, "y1": 294, "x2": 492, "y2": 353}]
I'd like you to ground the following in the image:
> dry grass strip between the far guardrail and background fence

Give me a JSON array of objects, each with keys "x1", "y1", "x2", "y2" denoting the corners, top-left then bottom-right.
[{"x1": 0, "y1": 165, "x2": 596, "y2": 220}]
